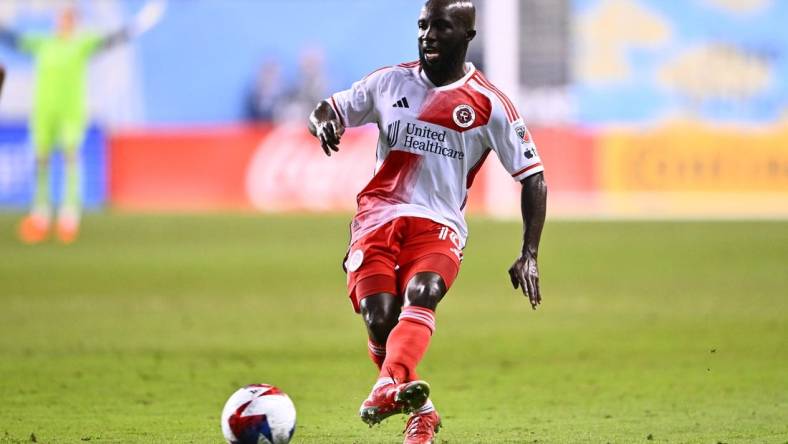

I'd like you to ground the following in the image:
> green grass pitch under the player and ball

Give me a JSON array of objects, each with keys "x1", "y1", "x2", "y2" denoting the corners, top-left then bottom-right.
[{"x1": 0, "y1": 214, "x2": 788, "y2": 444}]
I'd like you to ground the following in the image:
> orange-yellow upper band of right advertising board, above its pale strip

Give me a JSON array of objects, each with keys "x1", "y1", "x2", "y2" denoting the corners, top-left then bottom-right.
[{"x1": 599, "y1": 124, "x2": 788, "y2": 194}]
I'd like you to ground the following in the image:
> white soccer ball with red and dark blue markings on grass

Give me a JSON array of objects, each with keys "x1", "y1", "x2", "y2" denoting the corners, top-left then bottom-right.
[{"x1": 222, "y1": 384, "x2": 295, "y2": 444}]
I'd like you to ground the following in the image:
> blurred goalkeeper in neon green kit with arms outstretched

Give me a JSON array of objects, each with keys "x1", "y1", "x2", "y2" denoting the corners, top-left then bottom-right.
[{"x1": 0, "y1": 1, "x2": 164, "y2": 244}]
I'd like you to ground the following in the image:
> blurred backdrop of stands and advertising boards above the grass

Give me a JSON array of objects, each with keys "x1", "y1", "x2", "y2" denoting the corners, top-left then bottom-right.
[{"x1": 0, "y1": 0, "x2": 788, "y2": 218}]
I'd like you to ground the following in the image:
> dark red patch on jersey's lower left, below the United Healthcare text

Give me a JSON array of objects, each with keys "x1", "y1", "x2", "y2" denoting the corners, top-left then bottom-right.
[{"x1": 356, "y1": 151, "x2": 424, "y2": 213}]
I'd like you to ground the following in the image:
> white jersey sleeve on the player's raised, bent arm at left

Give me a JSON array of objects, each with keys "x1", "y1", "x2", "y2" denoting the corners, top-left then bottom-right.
[{"x1": 327, "y1": 70, "x2": 386, "y2": 127}]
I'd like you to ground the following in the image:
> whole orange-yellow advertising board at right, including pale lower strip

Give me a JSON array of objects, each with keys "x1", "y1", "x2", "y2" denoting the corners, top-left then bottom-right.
[{"x1": 599, "y1": 123, "x2": 788, "y2": 217}]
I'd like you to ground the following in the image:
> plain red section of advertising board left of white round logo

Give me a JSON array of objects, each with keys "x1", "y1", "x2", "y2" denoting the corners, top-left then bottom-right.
[{"x1": 109, "y1": 126, "x2": 270, "y2": 211}]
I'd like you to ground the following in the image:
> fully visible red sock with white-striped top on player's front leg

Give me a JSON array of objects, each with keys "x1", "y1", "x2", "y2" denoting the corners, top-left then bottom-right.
[{"x1": 380, "y1": 306, "x2": 435, "y2": 382}]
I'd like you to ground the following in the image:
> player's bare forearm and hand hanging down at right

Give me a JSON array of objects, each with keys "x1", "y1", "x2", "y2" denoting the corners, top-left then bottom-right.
[{"x1": 509, "y1": 172, "x2": 547, "y2": 310}]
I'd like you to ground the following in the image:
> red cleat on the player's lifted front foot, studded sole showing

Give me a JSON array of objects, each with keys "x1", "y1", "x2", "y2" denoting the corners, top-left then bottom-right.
[{"x1": 358, "y1": 381, "x2": 430, "y2": 427}]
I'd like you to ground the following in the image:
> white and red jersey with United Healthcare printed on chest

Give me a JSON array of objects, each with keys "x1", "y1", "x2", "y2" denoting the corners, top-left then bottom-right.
[{"x1": 328, "y1": 62, "x2": 544, "y2": 245}]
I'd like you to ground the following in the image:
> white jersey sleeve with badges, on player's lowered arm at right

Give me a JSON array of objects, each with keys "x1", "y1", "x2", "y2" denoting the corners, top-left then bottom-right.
[{"x1": 489, "y1": 114, "x2": 544, "y2": 182}]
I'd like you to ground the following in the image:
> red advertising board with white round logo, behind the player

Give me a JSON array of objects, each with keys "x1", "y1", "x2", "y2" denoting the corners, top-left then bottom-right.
[{"x1": 109, "y1": 126, "x2": 599, "y2": 212}]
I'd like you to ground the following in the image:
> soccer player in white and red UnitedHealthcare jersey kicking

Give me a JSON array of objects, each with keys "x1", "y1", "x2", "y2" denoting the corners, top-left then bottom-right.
[{"x1": 309, "y1": 0, "x2": 547, "y2": 444}]
